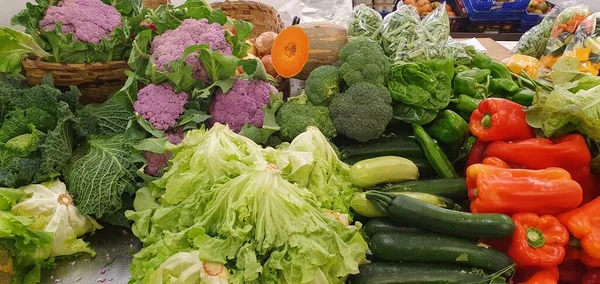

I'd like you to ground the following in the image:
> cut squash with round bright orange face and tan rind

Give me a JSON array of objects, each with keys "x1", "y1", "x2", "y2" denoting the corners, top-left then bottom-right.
[{"x1": 271, "y1": 23, "x2": 348, "y2": 80}]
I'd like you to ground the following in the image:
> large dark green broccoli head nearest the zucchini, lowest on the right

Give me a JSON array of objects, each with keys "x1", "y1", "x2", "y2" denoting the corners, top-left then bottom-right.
[{"x1": 329, "y1": 82, "x2": 394, "y2": 142}]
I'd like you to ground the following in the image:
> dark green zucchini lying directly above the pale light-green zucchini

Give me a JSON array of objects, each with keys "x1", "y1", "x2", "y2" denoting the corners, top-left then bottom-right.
[{"x1": 340, "y1": 135, "x2": 425, "y2": 164}]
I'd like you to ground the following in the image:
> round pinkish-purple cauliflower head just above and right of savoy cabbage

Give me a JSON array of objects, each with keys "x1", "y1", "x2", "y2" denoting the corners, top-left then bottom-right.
[{"x1": 133, "y1": 84, "x2": 188, "y2": 131}]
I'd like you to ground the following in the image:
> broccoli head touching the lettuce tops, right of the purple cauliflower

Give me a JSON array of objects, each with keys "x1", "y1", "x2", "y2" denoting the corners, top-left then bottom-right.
[{"x1": 277, "y1": 95, "x2": 337, "y2": 142}]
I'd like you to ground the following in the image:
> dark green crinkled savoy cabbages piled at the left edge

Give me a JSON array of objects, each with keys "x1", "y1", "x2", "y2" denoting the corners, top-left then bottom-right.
[{"x1": 0, "y1": 75, "x2": 137, "y2": 226}]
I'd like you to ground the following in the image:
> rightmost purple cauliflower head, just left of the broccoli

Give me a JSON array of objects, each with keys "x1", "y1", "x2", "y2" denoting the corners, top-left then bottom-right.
[{"x1": 209, "y1": 79, "x2": 277, "y2": 133}]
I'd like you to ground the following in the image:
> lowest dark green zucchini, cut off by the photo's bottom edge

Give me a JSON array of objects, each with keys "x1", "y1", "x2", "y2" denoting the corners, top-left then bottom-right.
[{"x1": 349, "y1": 262, "x2": 506, "y2": 284}]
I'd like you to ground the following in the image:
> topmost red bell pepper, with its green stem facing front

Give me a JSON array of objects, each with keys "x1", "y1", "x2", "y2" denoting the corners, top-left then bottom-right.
[{"x1": 469, "y1": 98, "x2": 535, "y2": 141}]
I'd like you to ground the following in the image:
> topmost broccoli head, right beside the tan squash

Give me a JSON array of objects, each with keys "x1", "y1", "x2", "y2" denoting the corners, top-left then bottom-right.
[{"x1": 339, "y1": 37, "x2": 392, "y2": 86}]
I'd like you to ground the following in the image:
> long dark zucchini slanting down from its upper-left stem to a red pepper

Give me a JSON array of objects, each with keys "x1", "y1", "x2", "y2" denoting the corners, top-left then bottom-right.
[{"x1": 366, "y1": 191, "x2": 515, "y2": 239}]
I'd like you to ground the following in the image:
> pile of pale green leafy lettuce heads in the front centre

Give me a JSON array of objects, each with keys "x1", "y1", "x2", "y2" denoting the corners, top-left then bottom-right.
[{"x1": 126, "y1": 124, "x2": 367, "y2": 283}]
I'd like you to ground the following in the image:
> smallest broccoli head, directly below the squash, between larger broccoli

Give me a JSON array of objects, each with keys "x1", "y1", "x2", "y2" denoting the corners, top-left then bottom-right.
[{"x1": 306, "y1": 65, "x2": 340, "y2": 106}]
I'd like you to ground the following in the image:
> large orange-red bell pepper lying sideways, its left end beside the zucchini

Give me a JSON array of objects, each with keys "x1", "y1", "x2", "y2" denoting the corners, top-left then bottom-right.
[{"x1": 466, "y1": 158, "x2": 582, "y2": 215}]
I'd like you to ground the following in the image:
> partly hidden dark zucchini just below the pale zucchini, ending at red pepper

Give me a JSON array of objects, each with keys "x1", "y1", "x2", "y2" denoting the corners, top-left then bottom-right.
[{"x1": 369, "y1": 178, "x2": 468, "y2": 202}]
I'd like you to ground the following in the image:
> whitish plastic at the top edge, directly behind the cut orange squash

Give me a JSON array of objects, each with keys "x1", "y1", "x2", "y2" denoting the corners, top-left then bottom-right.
[{"x1": 278, "y1": 0, "x2": 352, "y2": 27}]
